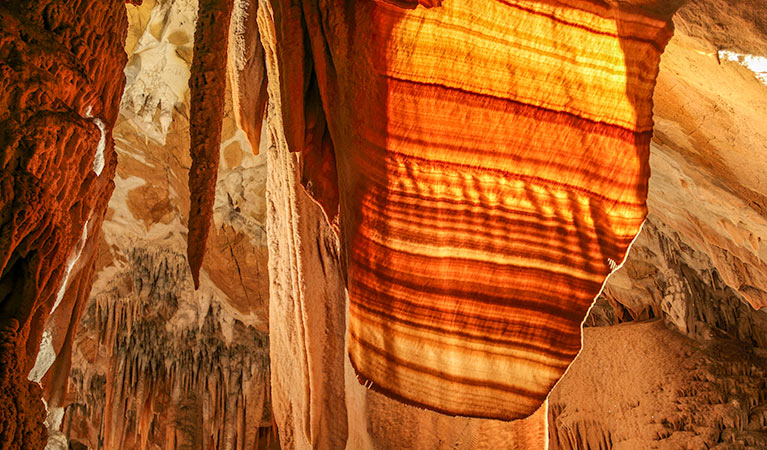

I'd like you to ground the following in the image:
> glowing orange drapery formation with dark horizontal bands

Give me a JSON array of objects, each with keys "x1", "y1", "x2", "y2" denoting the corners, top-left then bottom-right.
[{"x1": 190, "y1": 0, "x2": 672, "y2": 420}]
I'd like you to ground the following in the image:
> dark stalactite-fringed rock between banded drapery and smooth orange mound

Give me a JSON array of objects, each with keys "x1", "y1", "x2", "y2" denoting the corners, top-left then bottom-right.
[{"x1": 584, "y1": 217, "x2": 767, "y2": 349}]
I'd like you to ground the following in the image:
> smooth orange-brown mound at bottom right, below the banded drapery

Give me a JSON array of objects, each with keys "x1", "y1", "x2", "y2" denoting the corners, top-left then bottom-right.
[{"x1": 549, "y1": 321, "x2": 767, "y2": 450}]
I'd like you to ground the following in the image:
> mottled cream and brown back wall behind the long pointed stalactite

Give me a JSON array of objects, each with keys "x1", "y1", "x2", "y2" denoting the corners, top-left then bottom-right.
[{"x1": 56, "y1": 0, "x2": 277, "y2": 450}]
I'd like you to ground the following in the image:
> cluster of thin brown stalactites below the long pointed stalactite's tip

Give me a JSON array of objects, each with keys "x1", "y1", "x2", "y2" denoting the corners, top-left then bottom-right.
[{"x1": 62, "y1": 248, "x2": 276, "y2": 450}]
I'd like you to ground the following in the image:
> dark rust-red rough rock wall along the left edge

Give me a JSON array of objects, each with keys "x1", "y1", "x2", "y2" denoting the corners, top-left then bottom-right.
[{"x1": 0, "y1": 0, "x2": 127, "y2": 449}]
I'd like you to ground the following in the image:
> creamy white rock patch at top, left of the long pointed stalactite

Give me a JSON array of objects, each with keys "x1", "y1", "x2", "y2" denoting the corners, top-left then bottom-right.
[{"x1": 121, "y1": 0, "x2": 197, "y2": 144}]
